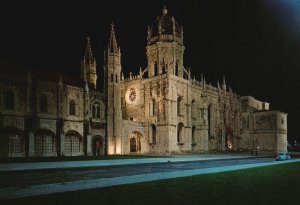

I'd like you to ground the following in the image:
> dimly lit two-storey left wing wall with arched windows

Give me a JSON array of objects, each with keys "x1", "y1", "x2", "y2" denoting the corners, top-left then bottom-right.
[{"x1": 0, "y1": 72, "x2": 106, "y2": 157}]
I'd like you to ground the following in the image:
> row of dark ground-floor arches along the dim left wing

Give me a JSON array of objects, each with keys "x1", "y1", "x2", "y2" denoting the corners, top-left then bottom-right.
[{"x1": 0, "y1": 127, "x2": 104, "y2": 157}]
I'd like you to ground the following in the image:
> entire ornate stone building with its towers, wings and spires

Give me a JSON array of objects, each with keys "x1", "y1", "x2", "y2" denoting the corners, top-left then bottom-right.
[{"x1": 0, "y1": 8, "x2": 287, "y2": 157}]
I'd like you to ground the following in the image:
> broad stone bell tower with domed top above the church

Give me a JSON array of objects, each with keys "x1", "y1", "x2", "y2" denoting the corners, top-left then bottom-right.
[{"x1": 146, "y1": 6, "x2": 185, "y2": 77}]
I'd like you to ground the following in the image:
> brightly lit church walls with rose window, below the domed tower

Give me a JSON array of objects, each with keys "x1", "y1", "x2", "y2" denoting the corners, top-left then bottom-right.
[{"x1": 122, "y1": 74, "x2": 239, "y2": 154}]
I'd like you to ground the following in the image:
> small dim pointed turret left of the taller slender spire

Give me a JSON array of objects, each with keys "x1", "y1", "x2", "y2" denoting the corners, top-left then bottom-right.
[{"x1": 81, "y1": 37, "x2": 97, "y2": 89}]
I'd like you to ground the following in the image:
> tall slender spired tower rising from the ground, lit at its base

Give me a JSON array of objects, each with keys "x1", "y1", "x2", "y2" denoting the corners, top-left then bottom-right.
[{"x1": 104, "y1": 24, "x2": 122, "y2": 154}]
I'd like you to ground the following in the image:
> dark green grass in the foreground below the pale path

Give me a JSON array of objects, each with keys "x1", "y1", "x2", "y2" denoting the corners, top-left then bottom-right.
[{"x1": 0, "y1": 163, "x2": 300, "y2": 205}]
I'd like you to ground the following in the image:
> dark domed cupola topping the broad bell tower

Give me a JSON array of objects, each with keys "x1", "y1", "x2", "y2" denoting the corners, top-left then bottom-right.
[{"x1": 147, "y1": 6, "x2": 183, "y2": 45}]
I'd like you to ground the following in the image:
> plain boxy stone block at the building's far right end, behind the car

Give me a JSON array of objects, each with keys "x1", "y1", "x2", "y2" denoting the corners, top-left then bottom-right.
[{"x1": 239, "y1": 96, "x2": 287, "y2": 153}]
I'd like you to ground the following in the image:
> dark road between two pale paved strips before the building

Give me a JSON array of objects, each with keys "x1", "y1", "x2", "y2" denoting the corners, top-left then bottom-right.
[{"x1": 0, "y1": 157, "x2": 274, "y2": 188}]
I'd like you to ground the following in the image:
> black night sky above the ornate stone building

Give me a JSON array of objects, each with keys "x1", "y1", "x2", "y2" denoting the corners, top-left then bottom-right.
[{"x1": 0, "y1": 0, "x2": 300, "y2": 141}]
